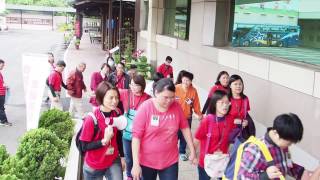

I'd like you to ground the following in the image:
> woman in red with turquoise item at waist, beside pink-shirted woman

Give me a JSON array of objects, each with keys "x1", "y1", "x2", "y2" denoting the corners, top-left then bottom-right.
[{"x1": 120, "y1": 75, "x2": 150, "y2": 180}]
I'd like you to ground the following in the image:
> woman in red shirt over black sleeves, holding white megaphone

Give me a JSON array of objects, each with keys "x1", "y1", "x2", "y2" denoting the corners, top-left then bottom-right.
[{"x1": 79, "y1": 82, "x2": 125, "y2": 180}]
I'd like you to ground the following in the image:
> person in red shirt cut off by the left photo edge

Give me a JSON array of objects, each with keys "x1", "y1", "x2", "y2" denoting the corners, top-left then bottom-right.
[{"x1": 0, "y1": 59, "x2": 12, "y2": 126}]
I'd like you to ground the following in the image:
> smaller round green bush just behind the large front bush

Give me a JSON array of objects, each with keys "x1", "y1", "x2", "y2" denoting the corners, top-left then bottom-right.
[{"x1": 39, "y1": 109, "x2": 74, "y2": 145}]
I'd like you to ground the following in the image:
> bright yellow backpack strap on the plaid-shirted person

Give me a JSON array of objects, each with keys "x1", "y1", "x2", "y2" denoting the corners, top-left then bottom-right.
[{"x1": 233, "y1": 136, "x2": 285, "y2": 180}]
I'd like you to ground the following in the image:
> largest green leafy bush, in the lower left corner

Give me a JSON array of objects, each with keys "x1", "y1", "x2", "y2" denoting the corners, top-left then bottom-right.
[{"x1": 3, "y1": 128, "x2": 67, "y2": 180}]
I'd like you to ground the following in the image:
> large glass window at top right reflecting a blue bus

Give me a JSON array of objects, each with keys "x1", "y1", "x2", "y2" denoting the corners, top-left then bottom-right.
[{"x1": 231, "y1": 0, "x2": 320, "y2": 65}]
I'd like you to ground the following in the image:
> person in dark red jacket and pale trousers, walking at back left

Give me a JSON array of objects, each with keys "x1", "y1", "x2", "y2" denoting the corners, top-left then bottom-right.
[{"x1": 67, "y1": 63, "x2": 87, "y2": 118}]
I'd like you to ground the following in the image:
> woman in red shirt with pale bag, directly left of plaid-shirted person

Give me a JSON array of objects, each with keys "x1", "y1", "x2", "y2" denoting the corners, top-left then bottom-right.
[{"x1": 194, "y1": 90, "x2": 231, "y2": 180}]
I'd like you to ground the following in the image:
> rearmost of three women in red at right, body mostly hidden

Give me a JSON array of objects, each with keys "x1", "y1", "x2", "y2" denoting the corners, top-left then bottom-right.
[{"x1": 202, "y1": 71, "x2": 229, "y2": 114}]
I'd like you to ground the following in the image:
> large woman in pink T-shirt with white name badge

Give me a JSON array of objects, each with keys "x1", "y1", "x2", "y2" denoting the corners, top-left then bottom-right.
[{"x1": 131, "y1": 78, "x2": 196, "y2": 180}]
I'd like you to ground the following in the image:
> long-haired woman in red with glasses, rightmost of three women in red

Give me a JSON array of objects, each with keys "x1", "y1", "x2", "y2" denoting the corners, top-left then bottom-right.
[{"x1": 229, "y1": 74, "x2": 250, "y2": 143}]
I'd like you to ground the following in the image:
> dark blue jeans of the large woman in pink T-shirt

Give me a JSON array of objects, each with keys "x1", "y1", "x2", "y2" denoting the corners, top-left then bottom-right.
[{"x1": 141, "y1": 162, "x2": 179, "y2": 180}]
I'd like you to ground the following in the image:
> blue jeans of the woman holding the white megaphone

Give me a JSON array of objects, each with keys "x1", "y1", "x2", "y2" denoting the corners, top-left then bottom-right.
[{"x1": 83, "y1": 158, "x2": 123, "y2": 180}]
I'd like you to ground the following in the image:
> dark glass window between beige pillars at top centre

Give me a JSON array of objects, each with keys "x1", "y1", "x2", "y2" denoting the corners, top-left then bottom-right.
[{"x1": 163, "y1": 0, "x2": 191, "y2": 40}]
